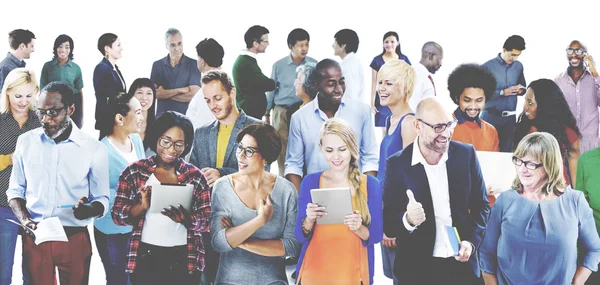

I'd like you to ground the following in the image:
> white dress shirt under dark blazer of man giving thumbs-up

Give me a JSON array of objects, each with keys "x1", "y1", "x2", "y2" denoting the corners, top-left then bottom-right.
[{"x1": 402, "y1": 136, "x2": 454, "y2": 258}]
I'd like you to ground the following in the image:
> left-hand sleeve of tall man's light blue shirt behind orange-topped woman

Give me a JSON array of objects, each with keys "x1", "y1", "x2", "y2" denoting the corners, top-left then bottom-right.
[{"x1": 285, "y1": 114, "x2": 306, "y2": 176}]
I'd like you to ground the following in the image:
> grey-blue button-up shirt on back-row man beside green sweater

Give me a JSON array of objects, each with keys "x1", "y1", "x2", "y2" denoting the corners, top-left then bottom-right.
[{"x1": 267, "y1": 54, "x2": 317, "y2": 110}]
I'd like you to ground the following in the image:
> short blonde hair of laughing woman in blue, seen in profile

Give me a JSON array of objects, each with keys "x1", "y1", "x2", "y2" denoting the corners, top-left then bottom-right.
[{"x1": 377, "y1": 59, "x2": 415, "y2": 103}]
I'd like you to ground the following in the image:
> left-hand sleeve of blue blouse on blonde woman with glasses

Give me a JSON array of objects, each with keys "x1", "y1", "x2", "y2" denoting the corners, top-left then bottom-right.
[{"x1": 479, "y1": 193, "x2": 507, "y2": 275}]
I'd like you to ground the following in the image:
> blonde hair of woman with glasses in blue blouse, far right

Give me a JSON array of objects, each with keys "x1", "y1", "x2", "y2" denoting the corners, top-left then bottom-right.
[{"x1": 512, "y1": 132, "x2": 567, "y2": 196}]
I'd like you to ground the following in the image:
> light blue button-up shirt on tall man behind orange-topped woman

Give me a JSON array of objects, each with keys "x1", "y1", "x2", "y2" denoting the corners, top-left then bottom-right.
[{"x1": 285, "y1": 95, "x2": 379, "y2": 176}]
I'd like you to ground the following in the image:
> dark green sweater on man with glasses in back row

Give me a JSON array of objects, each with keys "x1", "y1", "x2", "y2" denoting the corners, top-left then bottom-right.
[{"x1": 233, "y1": 54, "x2": 276, "y2": 120}]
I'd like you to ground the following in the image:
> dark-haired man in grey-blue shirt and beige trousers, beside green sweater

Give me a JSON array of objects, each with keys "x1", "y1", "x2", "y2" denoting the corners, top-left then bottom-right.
[{"x1": 267, "y1": 29, "x2": 317, "y2": 176}]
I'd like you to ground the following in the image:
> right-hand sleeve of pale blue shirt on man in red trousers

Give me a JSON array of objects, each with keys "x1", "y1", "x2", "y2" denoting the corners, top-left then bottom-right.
[{"x1": 88, "y1": 143, "x2": 110, "y2": 218}]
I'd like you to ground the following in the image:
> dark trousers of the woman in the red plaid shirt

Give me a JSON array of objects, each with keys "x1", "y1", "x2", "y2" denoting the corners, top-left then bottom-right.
[{"x1": 129, "y1": 243, "x2": 202, "y2": 285}]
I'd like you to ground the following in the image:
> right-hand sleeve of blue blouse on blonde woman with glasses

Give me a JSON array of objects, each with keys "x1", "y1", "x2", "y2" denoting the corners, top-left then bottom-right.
[{"x1": 577, "y1": 190, "x2": 600, "y2": 272}]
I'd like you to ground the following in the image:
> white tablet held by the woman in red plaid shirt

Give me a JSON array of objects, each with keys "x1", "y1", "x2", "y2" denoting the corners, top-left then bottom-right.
[{"x1": 148, "y1": 183, "x2": 194, "y2": 214}]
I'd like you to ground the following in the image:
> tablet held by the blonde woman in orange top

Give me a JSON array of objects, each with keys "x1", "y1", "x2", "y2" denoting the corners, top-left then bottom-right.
[{"x1": 310, "y1": 187, "x2": 352, "y2": 225}]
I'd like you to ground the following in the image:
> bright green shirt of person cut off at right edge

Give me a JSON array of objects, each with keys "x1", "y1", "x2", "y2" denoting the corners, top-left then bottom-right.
[{"x1": 575, "y1": 148, "x2": 600, "y2": 233}]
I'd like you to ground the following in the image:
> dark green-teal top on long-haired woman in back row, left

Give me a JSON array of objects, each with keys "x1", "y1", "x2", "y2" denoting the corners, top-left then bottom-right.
[{"x1": 40, "y1": 59, "x2": 83, "y2": 94}]
